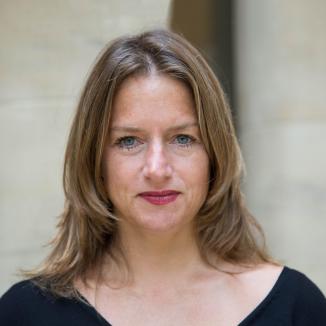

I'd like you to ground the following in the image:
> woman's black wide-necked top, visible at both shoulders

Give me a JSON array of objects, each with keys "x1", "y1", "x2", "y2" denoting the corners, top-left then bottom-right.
[{"x1": 0, "y1": 267, "x2": 326, "y2": 326}]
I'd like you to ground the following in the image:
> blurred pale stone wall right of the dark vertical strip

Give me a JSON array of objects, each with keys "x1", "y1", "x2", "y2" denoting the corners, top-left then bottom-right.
[{"x1": 234, "y1": 0, "x2": 326, "y2": 293}]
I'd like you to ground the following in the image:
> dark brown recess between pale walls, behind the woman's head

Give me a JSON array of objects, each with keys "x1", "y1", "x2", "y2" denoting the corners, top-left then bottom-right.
[{"x1": 169, "y1": 0, "x2": 234, "y2": 114}]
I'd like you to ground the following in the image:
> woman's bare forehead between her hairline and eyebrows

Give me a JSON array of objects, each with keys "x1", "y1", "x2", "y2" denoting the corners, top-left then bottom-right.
[{"x1": 110, "y1": 74, "x2": 197, "y2": 126}]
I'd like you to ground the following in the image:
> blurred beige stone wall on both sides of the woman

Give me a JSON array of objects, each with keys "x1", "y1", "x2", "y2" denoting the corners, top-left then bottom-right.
[{"x1": 0, "y1": 0, "x2": 326, "y2": 294}]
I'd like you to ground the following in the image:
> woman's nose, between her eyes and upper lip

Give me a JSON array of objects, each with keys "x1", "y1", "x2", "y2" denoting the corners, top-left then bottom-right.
[{"x1": 143, "y1": 141, "x2": 172, "y2": 182}]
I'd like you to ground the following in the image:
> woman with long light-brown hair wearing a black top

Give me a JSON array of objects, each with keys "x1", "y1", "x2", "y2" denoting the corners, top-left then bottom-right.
[{"x1": 0, "y1": 31, "x2": 326, "y2": 326}]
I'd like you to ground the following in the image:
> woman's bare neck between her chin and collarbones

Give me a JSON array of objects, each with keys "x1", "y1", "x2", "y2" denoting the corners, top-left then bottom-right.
[{"x1": 107, "y1": 223, "x2": 204, "y2": 288}]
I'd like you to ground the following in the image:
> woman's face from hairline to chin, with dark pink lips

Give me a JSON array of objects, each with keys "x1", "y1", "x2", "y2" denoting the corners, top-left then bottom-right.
[{"x1": 102, "y1": 75, "x2": 209, "y2": 231}]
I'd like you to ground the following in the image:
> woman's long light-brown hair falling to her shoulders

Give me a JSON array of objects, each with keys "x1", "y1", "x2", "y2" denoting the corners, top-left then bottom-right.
[{"x1": 25, "y1": 30, "x2": 271, "y2": 296}]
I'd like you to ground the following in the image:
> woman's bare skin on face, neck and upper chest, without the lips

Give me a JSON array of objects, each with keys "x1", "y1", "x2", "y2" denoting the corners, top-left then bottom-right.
[{"x1": 76, "y1": 74, "x2": 282, "y2": 326}]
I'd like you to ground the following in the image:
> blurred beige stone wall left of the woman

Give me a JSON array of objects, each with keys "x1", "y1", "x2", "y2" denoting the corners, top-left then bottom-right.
[{"x1": 0, "y1": 0, "x2": 170, "y2": 295}]
